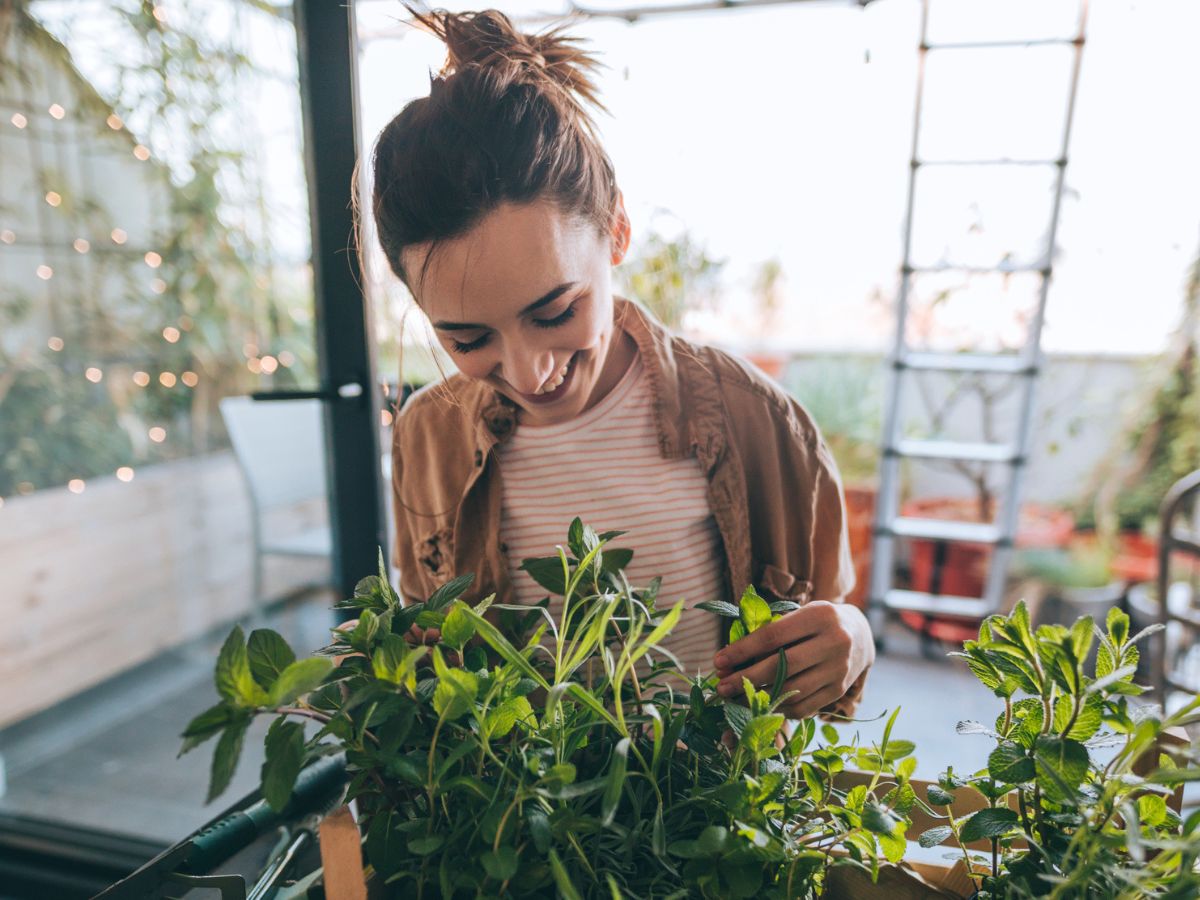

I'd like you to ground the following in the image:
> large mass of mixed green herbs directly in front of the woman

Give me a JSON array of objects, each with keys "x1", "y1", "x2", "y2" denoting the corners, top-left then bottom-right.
[{"x1": 184, "y1": 520, "x2": 922, "y2": 898}]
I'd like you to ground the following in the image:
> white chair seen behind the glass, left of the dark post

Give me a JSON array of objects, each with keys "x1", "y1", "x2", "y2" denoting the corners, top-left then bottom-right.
[{"x1": 221, "y1": 397, "x2": 334, "y2": 606}]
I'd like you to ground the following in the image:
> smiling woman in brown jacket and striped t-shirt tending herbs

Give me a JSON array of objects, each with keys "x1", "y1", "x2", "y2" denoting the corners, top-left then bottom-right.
[{"x1": 372, "y1": 11, "x2": 875, "y2": 718}]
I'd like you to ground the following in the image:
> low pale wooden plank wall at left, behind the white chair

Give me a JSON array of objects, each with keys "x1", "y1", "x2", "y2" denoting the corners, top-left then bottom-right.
[{"x1": 0, "y1": 452, "x2": 328, "y2": 727}]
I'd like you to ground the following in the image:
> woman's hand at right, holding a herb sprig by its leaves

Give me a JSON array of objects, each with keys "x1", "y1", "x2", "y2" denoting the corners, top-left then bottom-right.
[{"x1": 715, "y1": 600, "x2": 875, "y2": 719}]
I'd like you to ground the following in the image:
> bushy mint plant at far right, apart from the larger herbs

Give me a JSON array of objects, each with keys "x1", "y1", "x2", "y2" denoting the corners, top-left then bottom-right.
[{"x1": 936, "y1": 602, "x2": 1200, "y2": 899}]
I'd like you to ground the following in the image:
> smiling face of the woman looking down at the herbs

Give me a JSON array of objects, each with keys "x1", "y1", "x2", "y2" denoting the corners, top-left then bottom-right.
[{"x1": 402, "y1": 202, "x2": 629, "y2": 425}]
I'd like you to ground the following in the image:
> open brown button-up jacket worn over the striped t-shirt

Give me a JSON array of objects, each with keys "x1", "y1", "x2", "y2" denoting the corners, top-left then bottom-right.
[{"x1": 392, "y1": 298, "x2": 866, "y2": 715}]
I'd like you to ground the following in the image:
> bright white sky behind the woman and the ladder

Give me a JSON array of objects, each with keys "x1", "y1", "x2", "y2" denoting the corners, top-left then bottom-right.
[{"x1": 359, "y1": 0, "x2": 1200, "y2": 353}]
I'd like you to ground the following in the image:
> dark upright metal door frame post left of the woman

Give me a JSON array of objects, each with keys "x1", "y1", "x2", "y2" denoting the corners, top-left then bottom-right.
[{"x1": 293, "y1": 0, "x2": 388, "y2": 607}]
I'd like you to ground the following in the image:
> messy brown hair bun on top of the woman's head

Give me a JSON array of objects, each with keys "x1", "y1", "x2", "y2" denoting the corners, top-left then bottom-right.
[{"x1": 408, "y1": 6, "x2": 607, "y2": 125}]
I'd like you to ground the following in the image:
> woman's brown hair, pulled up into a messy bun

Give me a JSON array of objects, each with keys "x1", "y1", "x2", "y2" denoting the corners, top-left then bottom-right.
[{"x1": 372, "y1": 8, "x2": 617, "y2": 288}]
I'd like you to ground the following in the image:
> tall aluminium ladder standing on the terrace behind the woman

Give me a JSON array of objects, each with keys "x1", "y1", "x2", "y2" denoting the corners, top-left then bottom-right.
[{"x1": 869, "y1": 0, "x2": 1087, "y2": 644}]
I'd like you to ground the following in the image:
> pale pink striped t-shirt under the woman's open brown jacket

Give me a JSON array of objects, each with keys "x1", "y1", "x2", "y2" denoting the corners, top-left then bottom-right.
[{"x1": 499, "y1": 358, "x2": 727, "y2": 674}]
